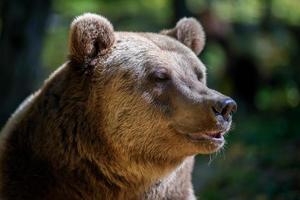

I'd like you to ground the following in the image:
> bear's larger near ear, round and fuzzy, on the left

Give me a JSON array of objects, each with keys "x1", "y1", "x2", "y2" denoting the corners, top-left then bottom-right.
[{"x1": 69, "y1": 13, "x2": 115, "y2": 63}]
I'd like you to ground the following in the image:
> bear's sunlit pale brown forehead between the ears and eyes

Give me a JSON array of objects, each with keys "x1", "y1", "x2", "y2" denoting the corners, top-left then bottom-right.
[{"x1": 105, "y1": 32, "x2": 206, "y2": 74}]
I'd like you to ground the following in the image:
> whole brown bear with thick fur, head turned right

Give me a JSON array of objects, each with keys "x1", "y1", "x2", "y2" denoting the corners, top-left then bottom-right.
[{"x1": 0, "y1": 14, "x2": 237, "y2": 200}]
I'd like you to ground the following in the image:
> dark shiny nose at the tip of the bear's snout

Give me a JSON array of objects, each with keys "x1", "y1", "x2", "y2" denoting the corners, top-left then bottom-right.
[{"x1": 212, "y1": 98, "x2": 237, "y2": 121}]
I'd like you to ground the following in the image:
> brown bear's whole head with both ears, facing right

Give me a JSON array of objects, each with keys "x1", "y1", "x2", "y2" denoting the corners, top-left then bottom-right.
[{"x1": 68, "y1": 14, "x2": 237, "y2": 166}]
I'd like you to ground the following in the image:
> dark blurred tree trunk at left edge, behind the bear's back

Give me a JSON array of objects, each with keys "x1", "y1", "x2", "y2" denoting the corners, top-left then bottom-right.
[{"x1": 0, "y1": 0, "x2": 51, "y2": 128}]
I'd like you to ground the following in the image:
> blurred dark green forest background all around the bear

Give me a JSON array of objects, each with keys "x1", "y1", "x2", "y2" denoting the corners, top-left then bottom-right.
[{"x1": 0, "y1": 0, "x2": 300, "y2": 200}]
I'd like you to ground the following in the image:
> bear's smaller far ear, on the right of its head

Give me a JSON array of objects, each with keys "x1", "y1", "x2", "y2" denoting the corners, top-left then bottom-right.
[{"x1": 161, "y1": 17, "x2": 205, "y2": 55}]
